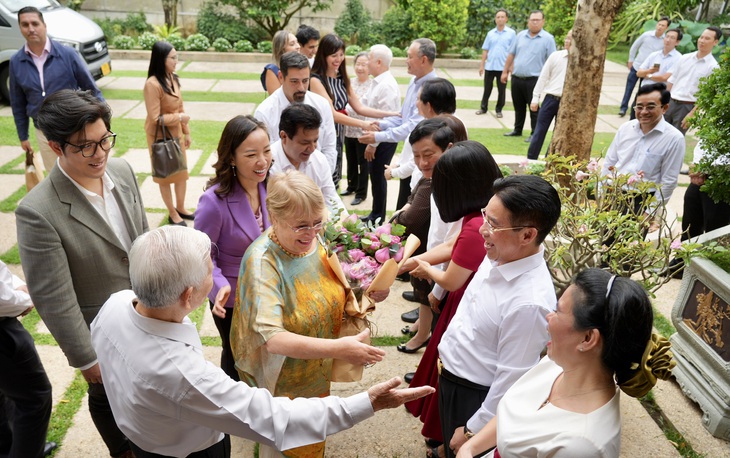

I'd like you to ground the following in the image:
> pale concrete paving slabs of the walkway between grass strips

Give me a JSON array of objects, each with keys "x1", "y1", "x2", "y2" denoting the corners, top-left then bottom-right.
[{"x1": 0, "y1": 55, "x2": 730, "y2": 458}]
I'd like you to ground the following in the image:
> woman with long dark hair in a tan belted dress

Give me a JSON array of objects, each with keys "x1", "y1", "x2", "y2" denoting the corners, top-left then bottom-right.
[{"x1": 144, "y1": 41, "x2": 195, "y2": 226}]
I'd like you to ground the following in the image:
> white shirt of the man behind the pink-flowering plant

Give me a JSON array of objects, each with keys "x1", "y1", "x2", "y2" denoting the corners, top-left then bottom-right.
[{"x1": 601, "y1": 118, "x2": 685, "y2": 203}]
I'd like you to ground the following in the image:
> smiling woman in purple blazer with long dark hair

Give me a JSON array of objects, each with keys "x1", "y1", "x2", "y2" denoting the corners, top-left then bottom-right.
[{"x1": 195, "y1": 116, "x2": 271, "y2": 380}]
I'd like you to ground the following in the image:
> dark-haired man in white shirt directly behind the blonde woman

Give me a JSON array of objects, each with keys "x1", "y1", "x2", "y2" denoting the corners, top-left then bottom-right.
[{"x1": 271, "y1": 103, "x2": 347, "y2": 217}]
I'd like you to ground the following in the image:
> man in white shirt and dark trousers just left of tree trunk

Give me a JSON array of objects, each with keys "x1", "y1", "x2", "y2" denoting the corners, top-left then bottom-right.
[{"x1": 527, "y1": 30, "x2": 573, "y2": 159}]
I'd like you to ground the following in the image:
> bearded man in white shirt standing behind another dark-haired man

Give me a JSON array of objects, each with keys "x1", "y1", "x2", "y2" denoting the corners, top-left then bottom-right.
[{"x1": 253, "y1": 52, "x2": 337, "y2": 175}]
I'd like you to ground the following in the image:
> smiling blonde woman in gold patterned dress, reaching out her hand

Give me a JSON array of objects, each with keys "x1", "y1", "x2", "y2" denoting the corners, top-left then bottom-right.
[{"x1": 231, "y1": 171, "x2": 387, "y2": 458}]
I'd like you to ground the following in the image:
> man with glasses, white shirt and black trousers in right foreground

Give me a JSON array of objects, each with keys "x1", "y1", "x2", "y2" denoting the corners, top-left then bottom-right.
[{"x1": 438, "y1": 175, "x2": 560, "y2": 458}]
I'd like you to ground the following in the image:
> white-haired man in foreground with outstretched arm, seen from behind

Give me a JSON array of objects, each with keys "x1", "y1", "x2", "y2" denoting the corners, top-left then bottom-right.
[{"x1": 91, "y1": 226, "x2": 434, "y2": 458}]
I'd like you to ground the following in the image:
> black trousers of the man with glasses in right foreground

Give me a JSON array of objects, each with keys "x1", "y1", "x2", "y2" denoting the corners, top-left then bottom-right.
[{"x1": 438, "y1": 370, "x2": 489, "y2": 458}]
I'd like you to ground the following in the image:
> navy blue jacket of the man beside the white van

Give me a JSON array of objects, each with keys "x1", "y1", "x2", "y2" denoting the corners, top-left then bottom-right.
[{"x1": 10, "y1": 40, "x2": 104, "y2": 141}]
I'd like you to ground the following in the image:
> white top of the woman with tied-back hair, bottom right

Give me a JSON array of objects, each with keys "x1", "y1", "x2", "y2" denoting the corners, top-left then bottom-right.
[{"x1": 487, "y1": 356, "x2": 620, "y2": 458}]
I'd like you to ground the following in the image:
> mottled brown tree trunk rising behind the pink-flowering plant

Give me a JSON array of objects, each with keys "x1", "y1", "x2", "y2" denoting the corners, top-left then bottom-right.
[{"x1": 548, "y1": 0, "x2": 624, "y2": 160}]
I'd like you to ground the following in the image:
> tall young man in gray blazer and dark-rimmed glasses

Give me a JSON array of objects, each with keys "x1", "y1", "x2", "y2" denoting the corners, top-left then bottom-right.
[{"x1": 15, "y1": 90, "x2": 148, "y2": 457}]
